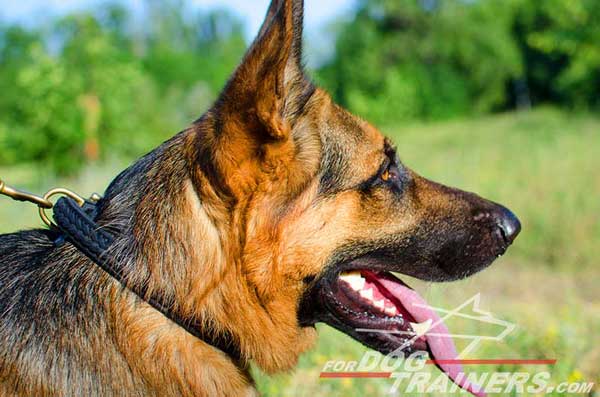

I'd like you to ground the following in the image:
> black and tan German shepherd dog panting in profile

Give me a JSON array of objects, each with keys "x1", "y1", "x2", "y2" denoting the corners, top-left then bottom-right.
[{"x1": 0, "y1": 0, "x2": 520, "y2": 397}]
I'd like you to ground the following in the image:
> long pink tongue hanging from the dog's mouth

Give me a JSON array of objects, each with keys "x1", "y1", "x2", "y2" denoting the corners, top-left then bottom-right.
[{"x1": 377, "y1": 278, "x2": 486, "y2": 397}]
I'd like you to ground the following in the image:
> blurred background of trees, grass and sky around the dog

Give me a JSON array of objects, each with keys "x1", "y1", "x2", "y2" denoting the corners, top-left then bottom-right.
[{"x1": 0, "y1": 0, "x2": 600, "y2": 396}]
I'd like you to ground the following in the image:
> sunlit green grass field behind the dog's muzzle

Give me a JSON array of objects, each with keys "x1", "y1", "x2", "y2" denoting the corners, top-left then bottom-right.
[{"x1": 0, "y1": 109, "x2": 600, "y2": 397}]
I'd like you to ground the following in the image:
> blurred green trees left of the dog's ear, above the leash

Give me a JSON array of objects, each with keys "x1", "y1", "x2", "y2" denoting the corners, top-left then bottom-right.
[{"x1": 0, "y1": 1, "x2": 245, "y2": 173}]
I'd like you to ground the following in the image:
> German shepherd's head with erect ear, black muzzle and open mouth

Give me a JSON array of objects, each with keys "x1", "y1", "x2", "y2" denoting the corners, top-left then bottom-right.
[{"x1": 186, "y1": 0, "x2": 520, "y2": 384}]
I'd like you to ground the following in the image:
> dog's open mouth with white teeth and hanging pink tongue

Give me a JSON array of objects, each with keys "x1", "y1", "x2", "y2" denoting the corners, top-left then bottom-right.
[{"x1": 319, "y1": 269, "x2": 485, "y2": 396}]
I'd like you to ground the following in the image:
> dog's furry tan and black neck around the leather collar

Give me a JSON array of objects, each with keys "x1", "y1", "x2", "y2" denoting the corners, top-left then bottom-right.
[{"x1": 89, "y1": 130, "x2": 315, "y2": 395}]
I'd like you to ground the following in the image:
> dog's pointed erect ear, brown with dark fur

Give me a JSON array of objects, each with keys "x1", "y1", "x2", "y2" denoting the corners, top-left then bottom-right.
[{"x1": 215, "y1": 0, "x2": 313, "y2": 140}]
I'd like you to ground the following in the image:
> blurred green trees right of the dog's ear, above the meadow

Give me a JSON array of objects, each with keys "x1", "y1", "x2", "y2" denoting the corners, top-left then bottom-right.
[{"x1": 319, "y1": 0, "x2": 600, "y2": 124}]
